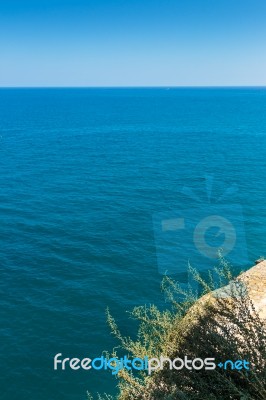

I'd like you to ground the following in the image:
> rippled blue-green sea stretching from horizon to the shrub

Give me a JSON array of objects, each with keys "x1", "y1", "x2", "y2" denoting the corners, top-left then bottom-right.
[{"x1": 0, "y1": 88, "x2": 266, "y2": 400}]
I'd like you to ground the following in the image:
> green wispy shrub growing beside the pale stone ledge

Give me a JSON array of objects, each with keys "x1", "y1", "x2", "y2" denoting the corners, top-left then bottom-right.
[{"x1": 89, "y1": 260, "x2": 266, "y2": 400}]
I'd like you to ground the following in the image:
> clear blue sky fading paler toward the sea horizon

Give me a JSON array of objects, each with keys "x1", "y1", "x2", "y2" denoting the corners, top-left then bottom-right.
[{"x1": 0, "y1": 0, "x2": 266, "y2": 87}]
